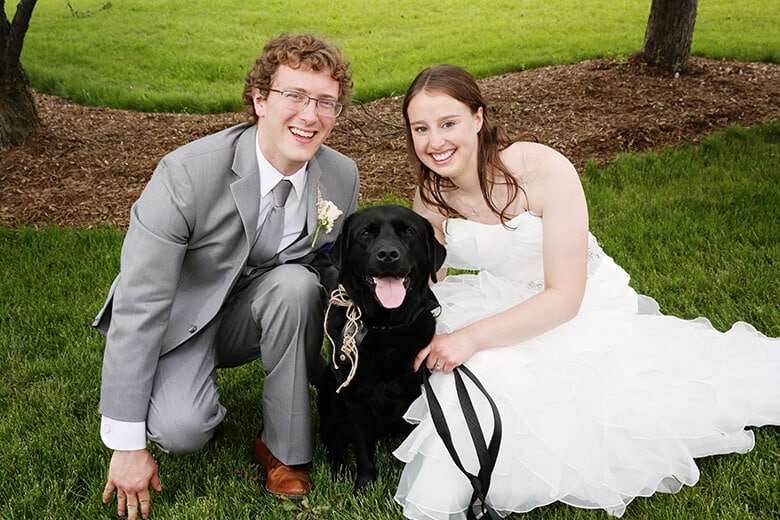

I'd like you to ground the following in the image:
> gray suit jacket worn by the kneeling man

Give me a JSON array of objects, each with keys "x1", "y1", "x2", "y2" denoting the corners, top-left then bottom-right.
[{"x1": 93, "y1": 123, "x2": 359, "y2": 422}]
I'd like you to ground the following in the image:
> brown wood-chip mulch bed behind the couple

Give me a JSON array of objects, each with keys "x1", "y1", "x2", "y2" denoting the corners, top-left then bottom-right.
[{"x1": 0, "y1": 57, "x2": 780, "y2": 226}]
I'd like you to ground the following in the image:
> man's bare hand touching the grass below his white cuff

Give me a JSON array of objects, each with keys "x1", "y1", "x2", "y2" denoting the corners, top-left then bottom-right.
[{"x1": 103, "y1": 449, "x2": 162, "y2": 520}]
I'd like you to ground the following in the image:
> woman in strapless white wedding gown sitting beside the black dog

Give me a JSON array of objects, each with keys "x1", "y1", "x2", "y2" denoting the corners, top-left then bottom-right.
[{"x1": 394, "y1": 65, "x2": 780, "y2": 519}]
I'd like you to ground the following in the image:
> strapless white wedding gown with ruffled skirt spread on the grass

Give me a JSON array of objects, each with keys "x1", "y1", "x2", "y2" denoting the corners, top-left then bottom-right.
[{"x1": 394, "y1": 213, "x2": 780, "y2": 519}]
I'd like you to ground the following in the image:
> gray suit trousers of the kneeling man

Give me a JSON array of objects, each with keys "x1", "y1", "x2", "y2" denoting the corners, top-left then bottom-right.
[{"x1": 146, "y1": 264, "x2": 325, "y2": 465}]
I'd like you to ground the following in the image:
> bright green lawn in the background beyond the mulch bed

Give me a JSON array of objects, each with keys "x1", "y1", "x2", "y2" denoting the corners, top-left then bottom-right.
[{"x1": 16, "y1": 0, "x2": 780, "y2": 113}]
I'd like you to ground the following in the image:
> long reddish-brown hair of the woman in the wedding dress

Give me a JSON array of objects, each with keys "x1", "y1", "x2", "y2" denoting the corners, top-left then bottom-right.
[{"x1": 403, "y1": 64, "x2": 525, "y2": 223}]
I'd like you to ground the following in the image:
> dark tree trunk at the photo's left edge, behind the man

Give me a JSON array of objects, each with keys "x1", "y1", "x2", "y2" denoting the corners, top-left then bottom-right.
[{"x1": 0, "y1": 0, "x2": 41, "y2": 152}]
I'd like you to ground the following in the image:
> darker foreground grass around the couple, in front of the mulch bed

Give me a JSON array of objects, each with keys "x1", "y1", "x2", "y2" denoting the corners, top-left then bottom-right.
[{"x1": 0, "y1": 121, "x2": 780, "y2": 520}]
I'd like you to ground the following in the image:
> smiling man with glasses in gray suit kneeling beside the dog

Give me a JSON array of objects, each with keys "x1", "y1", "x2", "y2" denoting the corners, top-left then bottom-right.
[{"x1": 94, "y1": 35, "x2": 358, "y2": 519}]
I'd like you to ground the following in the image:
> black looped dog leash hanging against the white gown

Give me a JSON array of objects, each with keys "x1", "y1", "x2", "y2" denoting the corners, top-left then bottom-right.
[{"x1": 422, "y1": 365, "x2": 501, "y2": 520}]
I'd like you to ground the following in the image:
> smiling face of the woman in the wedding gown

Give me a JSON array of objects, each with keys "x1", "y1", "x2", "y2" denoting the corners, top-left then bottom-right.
[{"x1": 407, "y1": 90, "x2": 482, "y2": 183}]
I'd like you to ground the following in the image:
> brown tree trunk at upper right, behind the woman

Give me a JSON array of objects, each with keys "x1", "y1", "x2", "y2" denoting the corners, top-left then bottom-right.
[{"x1": 642, "y1": 0, "x2": 699, "y2": 72}]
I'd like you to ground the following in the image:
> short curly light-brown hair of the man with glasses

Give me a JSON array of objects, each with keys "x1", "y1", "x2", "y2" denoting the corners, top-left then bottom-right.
[{"x1": 243, "y1": 34, "x2": 352, "y2": 123}]
